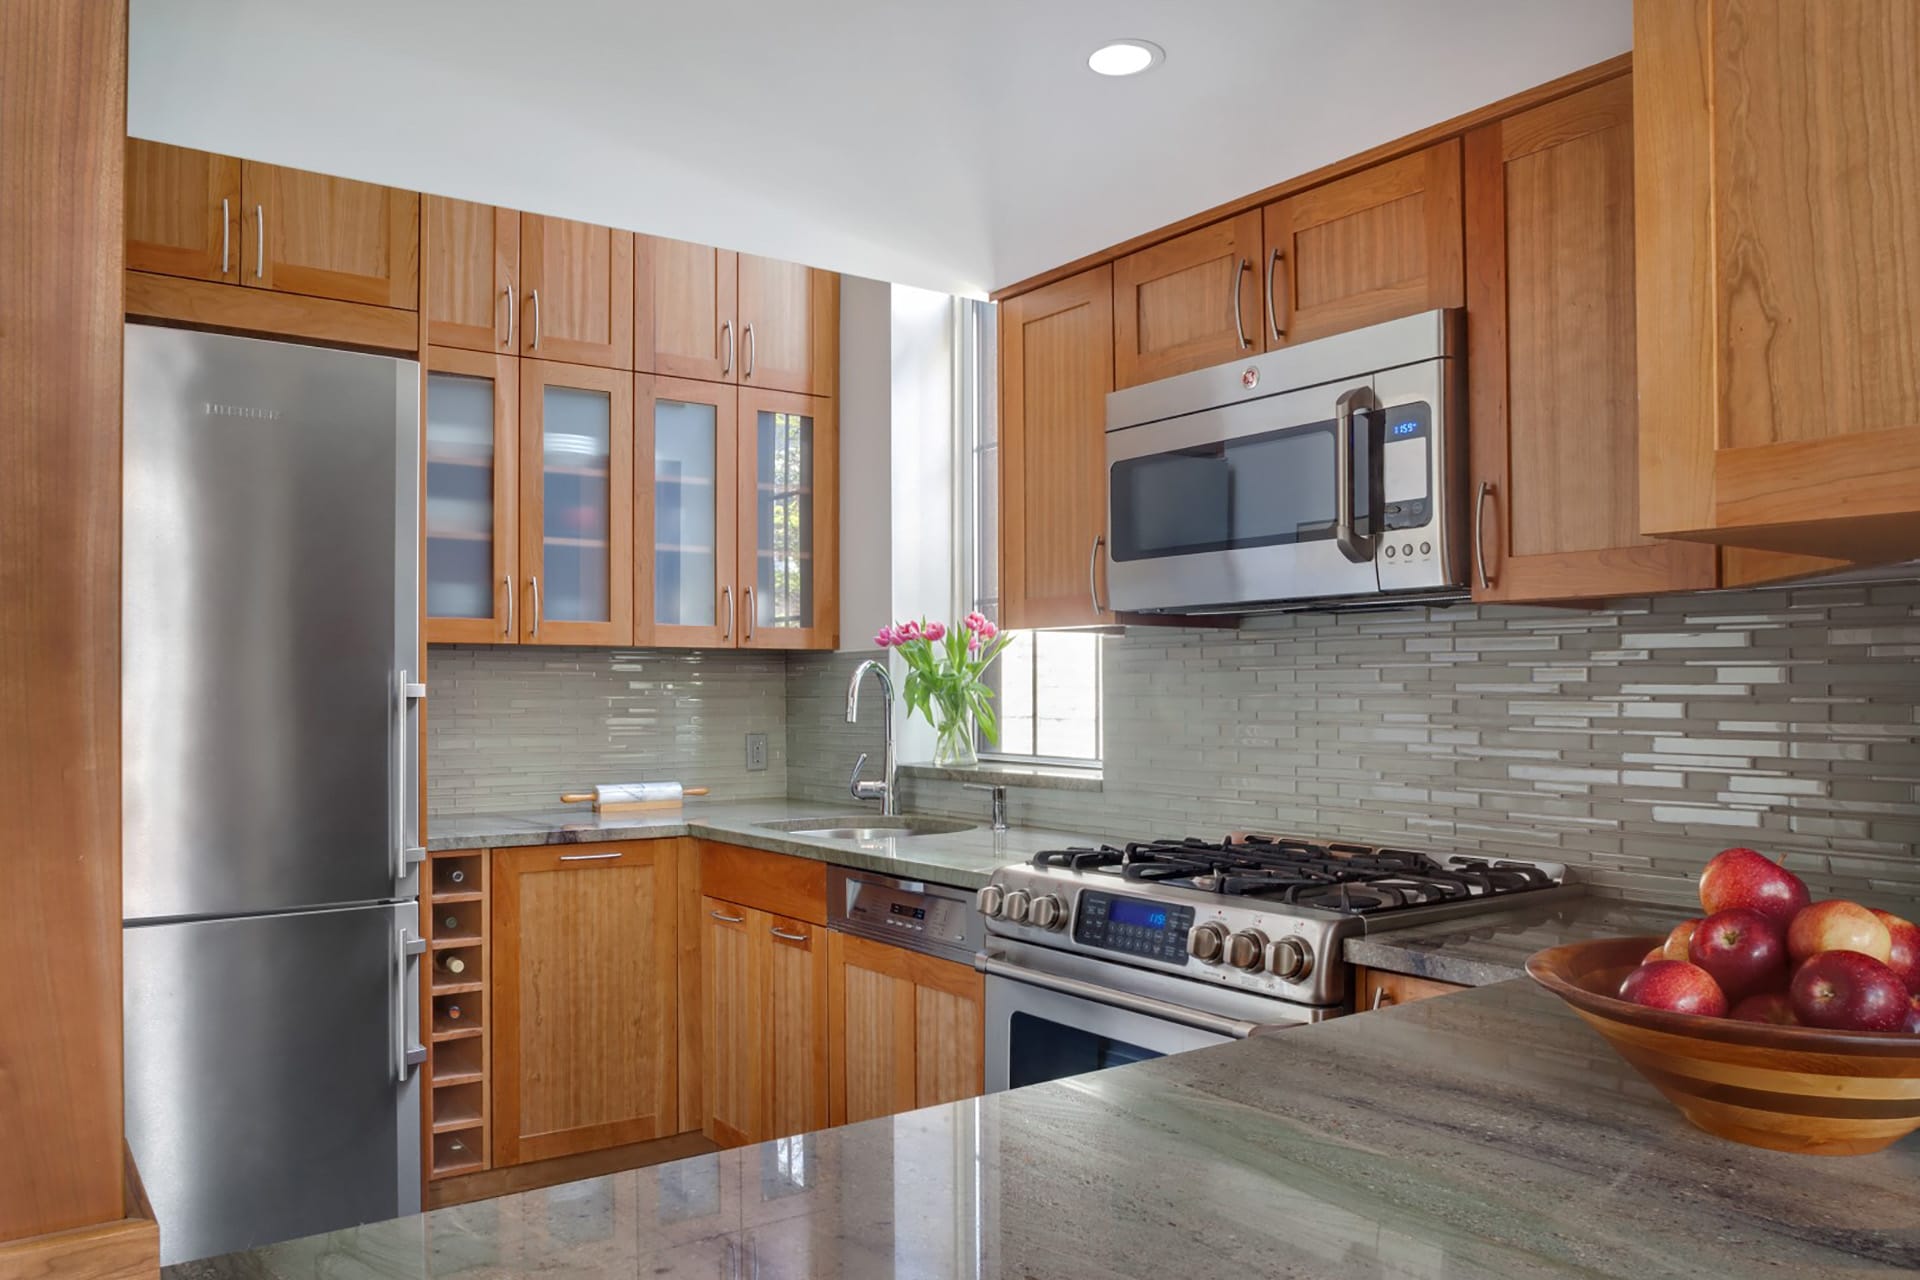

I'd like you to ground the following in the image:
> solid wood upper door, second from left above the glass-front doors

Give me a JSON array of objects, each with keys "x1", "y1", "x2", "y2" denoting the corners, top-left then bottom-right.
[{"x1": 520, "y1": 213, "x2": 634, "y2": 368}]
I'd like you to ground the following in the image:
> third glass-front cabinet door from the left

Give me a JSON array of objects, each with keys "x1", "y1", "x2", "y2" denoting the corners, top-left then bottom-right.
[{"x1": 634, "y1": 374, "x2": 739, "y2": 647}]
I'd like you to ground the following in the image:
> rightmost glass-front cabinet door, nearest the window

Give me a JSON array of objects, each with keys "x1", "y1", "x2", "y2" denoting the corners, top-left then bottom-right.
[{"x1": 737, "y1": 388, "x2": 839, "y2": 649}]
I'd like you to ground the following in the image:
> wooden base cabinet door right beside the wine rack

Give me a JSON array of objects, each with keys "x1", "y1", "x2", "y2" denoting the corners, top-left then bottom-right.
[{"x1": 492, "y1": 841, "x2": 680, "y2": 1167}]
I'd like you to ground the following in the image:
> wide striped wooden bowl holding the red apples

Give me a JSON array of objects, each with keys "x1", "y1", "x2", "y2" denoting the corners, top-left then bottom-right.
[{"x1": 1526, "y1": 936, "x2": 1920, "y2": 1155}]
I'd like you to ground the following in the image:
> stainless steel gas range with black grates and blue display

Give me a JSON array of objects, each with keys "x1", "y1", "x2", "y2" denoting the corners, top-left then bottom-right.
[{"x1": 975, "y1": 835, "x2": 1565, "y2": 1090}]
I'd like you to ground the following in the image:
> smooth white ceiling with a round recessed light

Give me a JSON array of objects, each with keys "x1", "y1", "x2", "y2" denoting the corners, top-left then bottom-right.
[{"x1": 129, "y1": 0, "x2": 1632, "y2": 294}]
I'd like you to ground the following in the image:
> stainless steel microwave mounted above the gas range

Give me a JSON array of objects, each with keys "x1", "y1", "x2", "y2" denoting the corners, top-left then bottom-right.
[{"x1": 1092, "y1": 311, "x2": 1467, "y2": 614}]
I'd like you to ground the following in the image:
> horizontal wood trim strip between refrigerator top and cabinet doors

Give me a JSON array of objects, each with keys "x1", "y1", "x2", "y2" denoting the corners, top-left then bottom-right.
[{"x1": 127, "y1": 271, "x2": 420, "y2": 357}]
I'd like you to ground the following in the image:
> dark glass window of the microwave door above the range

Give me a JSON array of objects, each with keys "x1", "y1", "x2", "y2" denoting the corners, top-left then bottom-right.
[{"x1": 1110, "y1": 410, "x2": 1375, "y2": 560}]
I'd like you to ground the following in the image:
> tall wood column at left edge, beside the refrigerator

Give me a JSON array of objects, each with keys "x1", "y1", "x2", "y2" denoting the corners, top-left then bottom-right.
[{"x1": 0, "y1": 0, "x2": 152, "y2": 1276}]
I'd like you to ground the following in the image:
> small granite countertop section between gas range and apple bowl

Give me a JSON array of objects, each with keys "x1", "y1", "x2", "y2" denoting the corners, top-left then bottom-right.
[{"x1": 1346, "y1": 894, "x2": 1697, "y2": 986}]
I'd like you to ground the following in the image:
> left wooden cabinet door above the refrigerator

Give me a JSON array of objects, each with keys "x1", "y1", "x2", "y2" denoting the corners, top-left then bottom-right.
[{"x1": 127, "y1": 138, "x2": 240, "y2": 284}]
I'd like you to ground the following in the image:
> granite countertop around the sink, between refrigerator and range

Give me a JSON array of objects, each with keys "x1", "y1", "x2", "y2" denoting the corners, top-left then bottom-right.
[{"x1": 426, "y1": 796, "x2": 1100, "y2": 889}]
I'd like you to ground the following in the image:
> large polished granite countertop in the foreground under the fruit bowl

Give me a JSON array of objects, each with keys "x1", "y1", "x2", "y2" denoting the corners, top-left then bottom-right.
[{"x1": 169, "y1": 981, "x2": 1920, "y2": 1280}]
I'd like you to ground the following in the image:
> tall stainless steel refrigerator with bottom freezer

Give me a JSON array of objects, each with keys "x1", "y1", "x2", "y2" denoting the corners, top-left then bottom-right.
[{"x1": 121, "y1": 324, "x2": 424, "y2": 1263}]
